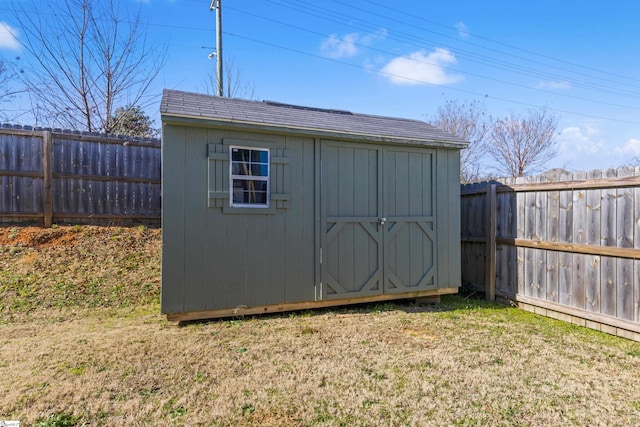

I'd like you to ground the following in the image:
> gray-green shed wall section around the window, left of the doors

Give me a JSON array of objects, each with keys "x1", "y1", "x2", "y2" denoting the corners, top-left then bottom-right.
[{"x1": 162, "y1": 125, "x2": 316, "y2": 313}]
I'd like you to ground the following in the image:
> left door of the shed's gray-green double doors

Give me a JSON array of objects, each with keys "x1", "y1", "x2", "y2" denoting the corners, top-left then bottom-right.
[{"x1": 320, "y1": 140, "x2": 382, "y2": 298}]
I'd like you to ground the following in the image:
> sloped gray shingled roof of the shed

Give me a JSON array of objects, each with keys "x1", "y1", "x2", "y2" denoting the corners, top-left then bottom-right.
[{"x1": 160, "y1": 89, "x2": 468, "y2": 148}]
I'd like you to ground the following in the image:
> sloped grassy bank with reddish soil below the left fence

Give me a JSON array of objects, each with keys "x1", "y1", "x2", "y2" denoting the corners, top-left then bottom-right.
[{"x1": 0, "y1": 226, "x2": 161, "y2": 322}]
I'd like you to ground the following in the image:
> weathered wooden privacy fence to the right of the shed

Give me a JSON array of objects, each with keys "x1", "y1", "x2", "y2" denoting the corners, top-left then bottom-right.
[{"x1": 461, "y1": 168, "x2": 640, "y2": 341}]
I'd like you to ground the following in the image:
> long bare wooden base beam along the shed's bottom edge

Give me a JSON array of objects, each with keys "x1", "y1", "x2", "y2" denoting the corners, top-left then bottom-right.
[{"x1": 167, "y1": 287, "x2": 458, "y2": 322}]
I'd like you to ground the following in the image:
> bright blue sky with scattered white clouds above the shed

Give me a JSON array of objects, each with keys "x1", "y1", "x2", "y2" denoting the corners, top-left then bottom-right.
[{"x1": 0, "y1": 0, "x2": 640, "y2": 174}]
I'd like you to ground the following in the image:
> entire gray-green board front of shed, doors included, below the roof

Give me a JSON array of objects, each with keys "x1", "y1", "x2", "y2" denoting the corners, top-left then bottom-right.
[{"x1": 161, "y1": 123, "x2": 460, "y2": 315}]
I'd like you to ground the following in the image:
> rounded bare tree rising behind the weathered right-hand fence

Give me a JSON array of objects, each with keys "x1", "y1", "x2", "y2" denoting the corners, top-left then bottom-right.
[{"x1": 487, "y1": 109, "x2": 558, "y2": 176}]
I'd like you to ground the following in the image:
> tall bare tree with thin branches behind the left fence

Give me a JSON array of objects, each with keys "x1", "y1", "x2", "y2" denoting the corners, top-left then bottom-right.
[{"x1": 10, "y1": 0, "x2": 165, "y2": 133}]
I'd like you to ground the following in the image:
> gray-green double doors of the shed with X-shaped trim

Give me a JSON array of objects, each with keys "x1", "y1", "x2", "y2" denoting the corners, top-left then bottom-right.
[{"x1": 320, "y1": 141, "x2": 436, "y2": 299}]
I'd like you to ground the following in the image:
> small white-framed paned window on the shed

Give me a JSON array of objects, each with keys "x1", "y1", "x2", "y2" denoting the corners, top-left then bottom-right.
[{"x1": 229, "y1": 146, "x2": 269, "y2": 208}]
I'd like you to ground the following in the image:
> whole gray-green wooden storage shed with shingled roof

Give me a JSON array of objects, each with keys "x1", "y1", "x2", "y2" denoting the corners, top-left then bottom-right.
[{"x1": 160, "y1": 90, "x2": 467, "y2": 320}]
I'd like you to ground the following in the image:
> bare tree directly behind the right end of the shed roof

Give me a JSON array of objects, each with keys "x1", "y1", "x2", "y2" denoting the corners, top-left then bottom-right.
[{"x1": 430, "y1": 101, "x2": 488, "y2": 182}]
